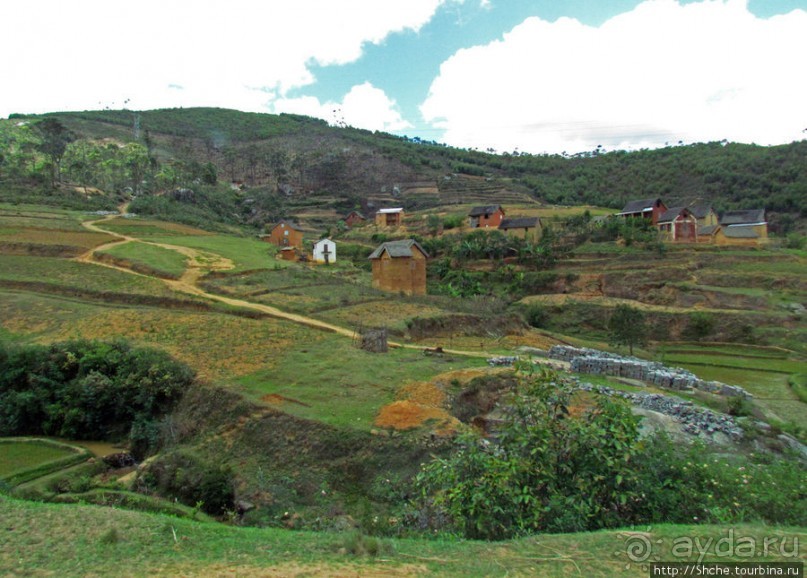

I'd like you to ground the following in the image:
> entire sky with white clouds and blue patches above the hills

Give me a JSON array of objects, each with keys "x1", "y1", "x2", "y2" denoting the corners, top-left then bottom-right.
[{"x1": 0, "y1": 0, "x2": 807, "y2": 154}]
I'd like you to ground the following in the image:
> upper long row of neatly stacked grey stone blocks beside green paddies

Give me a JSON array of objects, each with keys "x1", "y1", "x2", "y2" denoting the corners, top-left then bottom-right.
[{"x1": 549, "y1": 345, "x2": 751, "y2": 399}]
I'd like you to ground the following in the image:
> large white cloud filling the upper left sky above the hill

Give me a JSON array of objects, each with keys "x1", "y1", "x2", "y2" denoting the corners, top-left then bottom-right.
[{"x1": 0, "y1": 0, "x2": 446, "y2": 117}]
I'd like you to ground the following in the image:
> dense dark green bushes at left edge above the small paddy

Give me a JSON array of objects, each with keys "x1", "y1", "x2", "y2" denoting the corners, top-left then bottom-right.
[{"x1": 0, "y1": 341, "x2": 193, "y2": 456}]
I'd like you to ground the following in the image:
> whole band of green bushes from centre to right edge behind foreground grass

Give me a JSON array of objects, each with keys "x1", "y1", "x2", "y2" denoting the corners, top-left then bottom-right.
[{"x1": 413, "y1": 366, "x2": 807, "y2": 540}]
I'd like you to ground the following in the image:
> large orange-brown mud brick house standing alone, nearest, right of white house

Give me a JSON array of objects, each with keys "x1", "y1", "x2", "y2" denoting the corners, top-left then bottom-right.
[{"x1": 369, "y1": 239, "x2": 429, "y2": 295}]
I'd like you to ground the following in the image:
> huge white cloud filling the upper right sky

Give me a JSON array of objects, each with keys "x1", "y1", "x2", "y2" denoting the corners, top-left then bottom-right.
[{"x1": 421, "y1": 0, "x2": 807, "y2": 152}]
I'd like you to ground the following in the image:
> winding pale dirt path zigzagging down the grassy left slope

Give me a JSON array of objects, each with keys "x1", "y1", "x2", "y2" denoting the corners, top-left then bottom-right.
[{"x1": 75, "y1": 203, "x2": 491, "y2": 358}]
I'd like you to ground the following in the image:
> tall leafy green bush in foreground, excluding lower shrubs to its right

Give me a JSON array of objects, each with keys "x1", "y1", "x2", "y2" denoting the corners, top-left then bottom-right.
[{"x1": 417, "y1": 366, "x2": 638, "y2": 540}]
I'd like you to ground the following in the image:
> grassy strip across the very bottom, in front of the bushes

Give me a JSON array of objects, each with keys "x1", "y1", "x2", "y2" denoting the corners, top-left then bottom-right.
[{"x1": 0, "y1": 496, "x2": 807, "y2": 578}]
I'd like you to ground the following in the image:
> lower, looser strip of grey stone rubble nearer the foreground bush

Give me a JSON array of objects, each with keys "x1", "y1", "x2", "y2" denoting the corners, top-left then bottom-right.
[{"x1": 579, "y1": 383, "x2": 743, "y2": 441}]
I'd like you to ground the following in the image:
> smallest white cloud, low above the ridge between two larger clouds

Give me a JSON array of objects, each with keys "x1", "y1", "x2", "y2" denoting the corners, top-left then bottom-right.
[{"x1": 271, "y1": 82, "x2": 412, "y2": 132}]
